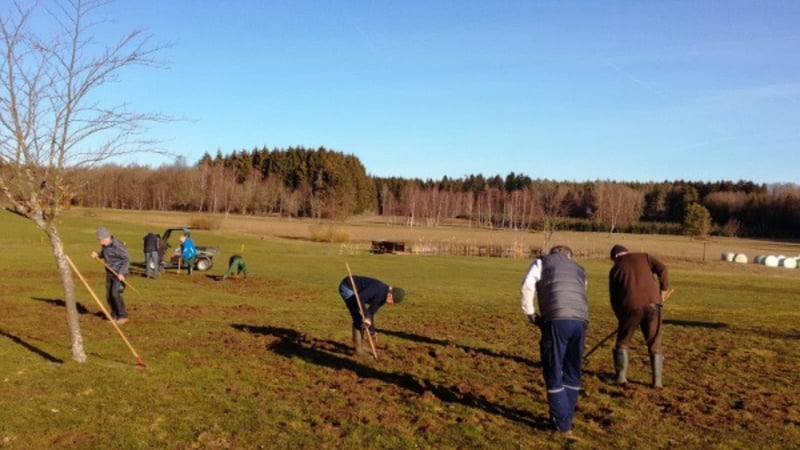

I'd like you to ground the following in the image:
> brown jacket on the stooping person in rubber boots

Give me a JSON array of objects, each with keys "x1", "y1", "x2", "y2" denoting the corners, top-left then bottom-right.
[{"x1": 608, "y1": 253, "x2": 669, "y2": 316}]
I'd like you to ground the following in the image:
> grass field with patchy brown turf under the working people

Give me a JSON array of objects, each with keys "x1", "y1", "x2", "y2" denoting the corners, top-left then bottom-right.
[{"x1": 0, "y1": 210, "x2": 800, "y2": 449}]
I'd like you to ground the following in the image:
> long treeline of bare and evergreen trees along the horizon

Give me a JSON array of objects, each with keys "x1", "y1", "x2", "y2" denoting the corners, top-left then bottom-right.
[{"x1": 69, "y1": 147, "x2": 800, "y2": 238}]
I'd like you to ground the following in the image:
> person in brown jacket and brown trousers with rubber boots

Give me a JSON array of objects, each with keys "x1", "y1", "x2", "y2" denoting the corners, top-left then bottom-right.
[{"x1": 608, "y1": 245, "x2": 669, "y2": 388}]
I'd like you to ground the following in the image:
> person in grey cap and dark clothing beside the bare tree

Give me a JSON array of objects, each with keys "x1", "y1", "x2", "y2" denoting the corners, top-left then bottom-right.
[{"x1": 92, "y1": 227, "x2": 131, "y2": 325}]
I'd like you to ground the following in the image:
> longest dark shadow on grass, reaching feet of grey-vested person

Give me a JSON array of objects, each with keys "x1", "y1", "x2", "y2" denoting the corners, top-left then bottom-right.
[{"x1": 231, "y1": 324, "x2": 552, "y2": 430}]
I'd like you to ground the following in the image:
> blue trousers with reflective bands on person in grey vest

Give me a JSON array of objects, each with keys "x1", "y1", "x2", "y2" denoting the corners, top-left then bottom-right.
[{"x1": 539, "y1": 320, "x2": 586, "y2": 431}]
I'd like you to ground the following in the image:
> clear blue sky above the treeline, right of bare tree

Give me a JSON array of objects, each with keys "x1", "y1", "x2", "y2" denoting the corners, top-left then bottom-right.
[{"x1": 92, "y1": 0, "x2": 800, "y2": 183}]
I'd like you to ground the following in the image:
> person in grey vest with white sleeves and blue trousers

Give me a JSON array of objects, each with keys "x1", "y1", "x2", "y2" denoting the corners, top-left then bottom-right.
[{"x1": 520, "y1": 245, "x2": 589, "y2": 439}]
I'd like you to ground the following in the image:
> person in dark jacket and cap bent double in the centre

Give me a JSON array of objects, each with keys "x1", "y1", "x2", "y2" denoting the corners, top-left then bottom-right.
[{"x1": 339, "y1": 275, "x2": 405, "y2": 356}]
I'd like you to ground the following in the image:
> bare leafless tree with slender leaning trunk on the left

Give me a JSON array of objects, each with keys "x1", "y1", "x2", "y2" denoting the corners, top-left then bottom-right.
[{"x1": 0, "y1": 0, "x2": 166, "y2": 362}]
